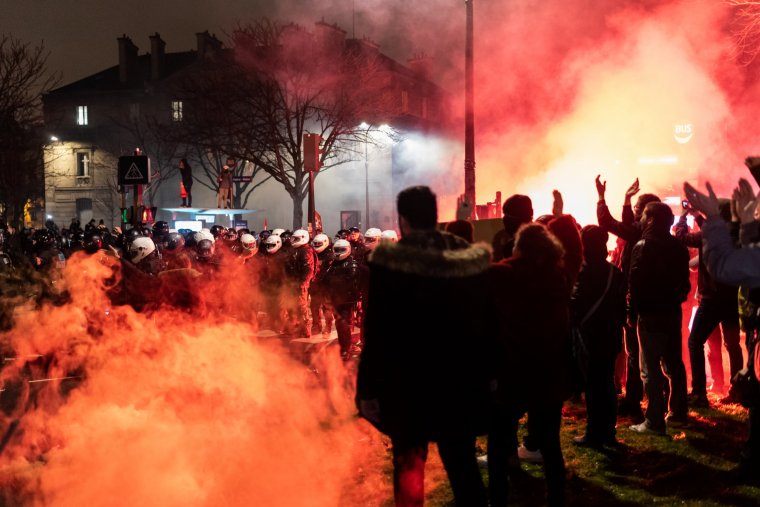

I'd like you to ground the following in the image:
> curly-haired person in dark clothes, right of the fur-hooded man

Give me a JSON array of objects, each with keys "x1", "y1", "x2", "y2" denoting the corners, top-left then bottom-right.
[{"x1": 488, "y1": 224, "x2": 570, "y2": 506}]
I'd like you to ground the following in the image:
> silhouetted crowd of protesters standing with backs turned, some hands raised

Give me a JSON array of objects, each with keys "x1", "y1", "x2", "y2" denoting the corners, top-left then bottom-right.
[{"x1": 356, "y1": 173, "x2": 760, "y2": 506}]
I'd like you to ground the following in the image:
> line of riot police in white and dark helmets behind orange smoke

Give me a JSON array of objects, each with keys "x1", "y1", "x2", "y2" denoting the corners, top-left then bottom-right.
[{"x1": 0, "y1": 221, "x2": 397, "y2": 359}]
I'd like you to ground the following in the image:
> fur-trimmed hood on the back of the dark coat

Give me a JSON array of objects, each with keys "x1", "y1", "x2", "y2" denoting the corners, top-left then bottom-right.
[{"x1": 369, "y1": 231, "x2": 491, "y2": 278}]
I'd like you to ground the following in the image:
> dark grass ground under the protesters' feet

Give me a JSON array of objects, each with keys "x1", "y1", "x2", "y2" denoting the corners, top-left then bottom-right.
[{"x1": 347, "y1": 392, "x2": 760, "y2": 507}]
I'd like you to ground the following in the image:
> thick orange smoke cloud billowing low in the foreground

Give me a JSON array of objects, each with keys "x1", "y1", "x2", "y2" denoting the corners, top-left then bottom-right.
[{"x1": 0, "y1": 255, "x2": 391, "y2": 506}]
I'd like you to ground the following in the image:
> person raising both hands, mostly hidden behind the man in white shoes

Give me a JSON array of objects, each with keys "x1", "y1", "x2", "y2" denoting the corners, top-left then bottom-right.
[{"x1": 596, "y1": 176, "x2": 660, "y2": 422}]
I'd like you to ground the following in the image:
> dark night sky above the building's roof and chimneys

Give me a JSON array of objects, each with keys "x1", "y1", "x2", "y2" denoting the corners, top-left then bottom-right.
[{"x1": 0, "y1": 0, "x2": 452, "y2": 84}]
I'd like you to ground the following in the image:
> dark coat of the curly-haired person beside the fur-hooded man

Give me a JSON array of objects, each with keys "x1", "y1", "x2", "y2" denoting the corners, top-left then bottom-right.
[{"x1": 488, "y1": 257, "x2": 570, "y2": 407}]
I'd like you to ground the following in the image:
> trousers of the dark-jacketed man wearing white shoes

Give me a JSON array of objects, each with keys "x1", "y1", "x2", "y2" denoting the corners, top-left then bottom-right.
[{"x1": 638, "y1": 308, "x2": 687, "y2": 430}]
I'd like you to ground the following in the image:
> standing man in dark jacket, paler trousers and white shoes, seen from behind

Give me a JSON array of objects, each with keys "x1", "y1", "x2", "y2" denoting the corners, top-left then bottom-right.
[{"x1": 628, "y1": 202, "x2": 691, "y2": 434}]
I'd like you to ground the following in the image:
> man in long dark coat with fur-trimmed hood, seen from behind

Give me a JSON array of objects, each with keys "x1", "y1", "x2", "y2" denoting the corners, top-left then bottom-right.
[{"x1": 357, "y1": 186, "x2": 490, "y2": 507}]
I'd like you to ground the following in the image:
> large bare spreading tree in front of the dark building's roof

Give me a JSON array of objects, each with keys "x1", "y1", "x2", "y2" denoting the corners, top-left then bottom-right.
[{"x1": 174, "y1": 19, "x2": 392, "y2": 228}]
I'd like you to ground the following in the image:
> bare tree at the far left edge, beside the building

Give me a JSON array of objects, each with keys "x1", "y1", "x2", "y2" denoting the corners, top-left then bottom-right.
[{"x1": 0, "y1": 34, "x2": 59, "y2": 224}]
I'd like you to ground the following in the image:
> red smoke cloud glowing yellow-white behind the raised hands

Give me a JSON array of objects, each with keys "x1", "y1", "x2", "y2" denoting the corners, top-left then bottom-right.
[{"x1": 310, "y1": 0, "x2": 760, "y2": 222}]
